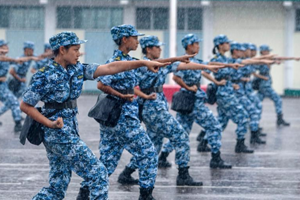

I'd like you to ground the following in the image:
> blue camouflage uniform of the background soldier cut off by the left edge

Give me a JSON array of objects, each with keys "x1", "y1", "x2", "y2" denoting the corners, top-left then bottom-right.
[{"x1": 0, "y1": 62, "x2": 21, "y2": 122}]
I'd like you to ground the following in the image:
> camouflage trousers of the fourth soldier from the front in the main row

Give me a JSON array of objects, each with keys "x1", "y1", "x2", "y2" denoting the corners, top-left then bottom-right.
[{"x1": 162, "y1": 99, "x2": 222, "y2": 153}]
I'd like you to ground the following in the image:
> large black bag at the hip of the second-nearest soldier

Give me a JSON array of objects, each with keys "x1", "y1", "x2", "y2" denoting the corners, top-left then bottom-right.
[{"x1": 88, "y1": 93, "x2": 125, "y2": 127}]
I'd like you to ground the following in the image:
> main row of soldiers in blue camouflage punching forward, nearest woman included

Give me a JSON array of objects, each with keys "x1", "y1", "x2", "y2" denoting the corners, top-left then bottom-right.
[{"x1": 14, "y1": 25, "x2": 298, "y2": 200}]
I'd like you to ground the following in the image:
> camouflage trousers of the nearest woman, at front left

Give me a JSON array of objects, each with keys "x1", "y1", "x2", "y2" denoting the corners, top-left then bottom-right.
[{"x1": 33, "y1": 138, "x2": 109, "y2": 200}]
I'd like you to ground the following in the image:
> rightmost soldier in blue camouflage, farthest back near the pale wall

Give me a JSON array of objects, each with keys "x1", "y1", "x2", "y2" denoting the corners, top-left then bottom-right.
[{"x1": 257, "y1": 45, "x2": 290, "y2": 126}]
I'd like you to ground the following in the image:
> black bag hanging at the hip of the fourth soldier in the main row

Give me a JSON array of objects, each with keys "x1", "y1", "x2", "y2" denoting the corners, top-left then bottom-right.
[{"x1": 171, "y1": 90, "x2": 196, "y2": 114}]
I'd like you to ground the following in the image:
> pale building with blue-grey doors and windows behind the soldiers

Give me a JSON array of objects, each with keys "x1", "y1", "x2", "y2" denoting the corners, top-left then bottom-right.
[{"x1": 0, "y1": 0, "x2": 300, "y2": 94}]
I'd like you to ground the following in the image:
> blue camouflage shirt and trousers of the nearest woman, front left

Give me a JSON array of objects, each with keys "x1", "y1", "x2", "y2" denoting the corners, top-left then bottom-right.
[{"x1": 23, "y1": 59, "x2": 109, "y2": 200}]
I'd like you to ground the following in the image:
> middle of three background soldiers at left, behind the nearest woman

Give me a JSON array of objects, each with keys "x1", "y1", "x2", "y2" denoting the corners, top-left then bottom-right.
[{"x1": 8, "y1": 41, "x2": 34, "y2": 98}]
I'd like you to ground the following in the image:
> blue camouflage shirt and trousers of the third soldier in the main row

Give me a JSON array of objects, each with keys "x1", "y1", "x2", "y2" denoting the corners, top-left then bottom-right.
[{"x1": 127, "y1": 57, "x2": 190, "y2": 169}]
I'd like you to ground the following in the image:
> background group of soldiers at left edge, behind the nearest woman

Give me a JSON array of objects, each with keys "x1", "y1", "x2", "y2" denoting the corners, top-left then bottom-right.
[{"x1": 0, "y1": 39, "x2": 52, "y2": 133}]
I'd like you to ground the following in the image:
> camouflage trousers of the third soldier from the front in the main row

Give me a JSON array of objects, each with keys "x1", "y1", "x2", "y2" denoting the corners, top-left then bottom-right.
[{"x1": 127, "y1": 106, "x2": 190, "y2": 169}]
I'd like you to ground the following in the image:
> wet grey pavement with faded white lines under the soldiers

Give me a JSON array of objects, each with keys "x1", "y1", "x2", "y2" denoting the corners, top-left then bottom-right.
[{"x1": 0, "y1": 96, "x2": 300, "y2": 200}]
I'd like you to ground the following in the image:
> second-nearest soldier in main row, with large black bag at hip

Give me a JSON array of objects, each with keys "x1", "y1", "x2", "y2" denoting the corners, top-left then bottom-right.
[{"x1": 75, "y1": 24, "x2": 168, "y2": 200}]
